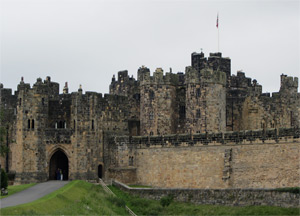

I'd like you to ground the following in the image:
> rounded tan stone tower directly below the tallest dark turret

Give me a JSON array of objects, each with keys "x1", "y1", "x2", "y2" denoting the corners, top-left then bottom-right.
[{"x1": 186, "y1": 64, "x2": 226, "y2": 133}]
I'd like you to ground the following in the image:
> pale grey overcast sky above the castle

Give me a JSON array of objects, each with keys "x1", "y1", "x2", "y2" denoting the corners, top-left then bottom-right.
[{"x1": 0, "y1": 0, "x2": 300, "y2": 93}]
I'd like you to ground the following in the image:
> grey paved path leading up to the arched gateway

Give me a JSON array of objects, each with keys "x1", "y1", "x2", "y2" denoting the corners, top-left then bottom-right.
[{"x1": 0, "y1": 181, "x2": 69, "y2": 208}]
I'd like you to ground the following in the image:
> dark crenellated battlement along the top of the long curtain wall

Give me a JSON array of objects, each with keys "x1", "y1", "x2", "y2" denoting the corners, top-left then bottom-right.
[{"x1": 111, "y1": 128, "x2": 300, "y2": 148}]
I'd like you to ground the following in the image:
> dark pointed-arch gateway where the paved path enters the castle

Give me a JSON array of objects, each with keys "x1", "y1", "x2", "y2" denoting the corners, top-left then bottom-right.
[{"x1": 49, "y1": 149, "x2": 69, "y2": 180}]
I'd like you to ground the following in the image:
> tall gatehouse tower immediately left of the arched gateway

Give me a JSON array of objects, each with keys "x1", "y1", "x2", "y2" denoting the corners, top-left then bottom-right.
[{"x1": 11, "y1": 78, "x2": 59, "y2": 182}]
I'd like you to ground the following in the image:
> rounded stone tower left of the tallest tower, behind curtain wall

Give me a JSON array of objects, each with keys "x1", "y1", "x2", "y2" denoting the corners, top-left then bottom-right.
[{"x1": 138, "y1": 67, "x2": 176, "y2": 135}]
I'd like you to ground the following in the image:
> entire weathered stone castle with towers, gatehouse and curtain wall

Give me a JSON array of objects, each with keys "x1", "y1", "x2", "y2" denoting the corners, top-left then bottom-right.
[{"x1": 1, "y1": 52, "x2": 300, "y2": 188}]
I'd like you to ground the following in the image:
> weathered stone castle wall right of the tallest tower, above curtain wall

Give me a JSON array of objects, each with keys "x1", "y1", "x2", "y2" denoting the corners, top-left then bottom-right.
[{"x1": 226, "y1": 72, "x2": 300, "y2": 131}]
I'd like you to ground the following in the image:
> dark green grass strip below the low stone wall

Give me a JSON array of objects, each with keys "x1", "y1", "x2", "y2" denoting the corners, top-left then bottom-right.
[{"x1": 109, "y1": 186, "x2": 300, "y2": 215}]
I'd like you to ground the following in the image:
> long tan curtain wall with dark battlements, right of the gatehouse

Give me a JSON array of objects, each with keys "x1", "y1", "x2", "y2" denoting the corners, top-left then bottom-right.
[{"x1": 109, "y1": 128, "x2": 300, "y2": 189}]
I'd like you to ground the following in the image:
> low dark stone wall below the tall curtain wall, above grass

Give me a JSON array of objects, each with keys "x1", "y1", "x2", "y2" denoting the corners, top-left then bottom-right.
[{"x1": 112, "y1": 181, "x2": 300, "y2": 208}]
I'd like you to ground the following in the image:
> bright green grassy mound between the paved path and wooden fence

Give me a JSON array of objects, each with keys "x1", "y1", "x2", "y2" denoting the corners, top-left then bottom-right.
[{"x1": 1, "y1": 180, "x2": 128, "y2": 215}]
